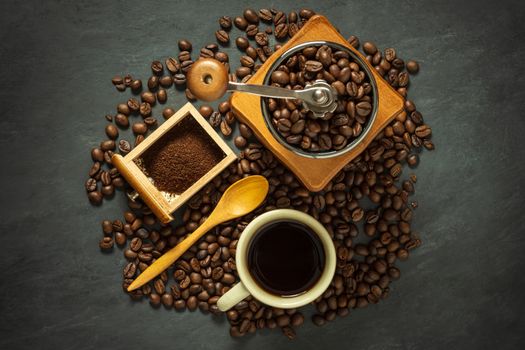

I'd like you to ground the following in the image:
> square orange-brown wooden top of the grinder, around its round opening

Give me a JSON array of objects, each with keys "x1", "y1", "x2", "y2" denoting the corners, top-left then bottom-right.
[{"x1": 231, "y1": 15, "x2": 404, "y2": 192}]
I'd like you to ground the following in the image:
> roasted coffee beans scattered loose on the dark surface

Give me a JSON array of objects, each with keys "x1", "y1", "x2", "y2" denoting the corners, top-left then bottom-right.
[{"x1": 86, "y1": 9, "x2": 434, "y2": 339}]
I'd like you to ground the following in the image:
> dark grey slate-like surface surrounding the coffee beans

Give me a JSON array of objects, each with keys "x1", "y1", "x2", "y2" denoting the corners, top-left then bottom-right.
[{"x1": 0, "y1": 0, "x2": 525, "y2": 349}]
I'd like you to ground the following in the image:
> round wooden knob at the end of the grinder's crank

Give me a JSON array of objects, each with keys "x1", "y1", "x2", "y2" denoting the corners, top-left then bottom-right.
[{"x1": 188, "y1": 58, "x2": 228, "y2": 101}]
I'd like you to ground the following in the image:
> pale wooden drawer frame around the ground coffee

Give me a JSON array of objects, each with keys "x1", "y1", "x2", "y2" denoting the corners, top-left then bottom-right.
[{"x1": 112, "y1": 102, "x2": 237, "y2": 223}]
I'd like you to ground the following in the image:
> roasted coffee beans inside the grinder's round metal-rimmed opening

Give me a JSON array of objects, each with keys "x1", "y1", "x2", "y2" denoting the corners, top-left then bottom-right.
[{"x1": 266, "y1": 45, "x2": 374, "y2": 153}]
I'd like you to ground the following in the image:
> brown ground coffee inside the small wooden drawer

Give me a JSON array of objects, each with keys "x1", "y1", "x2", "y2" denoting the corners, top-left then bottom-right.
[{"x1": 142, "y1": 117, "x2": 224, "y2": 194}]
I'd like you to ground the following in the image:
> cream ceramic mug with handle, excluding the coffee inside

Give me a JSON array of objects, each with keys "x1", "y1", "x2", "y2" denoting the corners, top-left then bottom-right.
[{"x1": 217, "y1": 209, "x2": 336, "y2": 311}]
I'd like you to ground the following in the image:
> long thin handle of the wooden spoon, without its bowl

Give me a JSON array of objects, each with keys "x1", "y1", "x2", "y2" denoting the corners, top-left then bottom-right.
[{"x1": 128, "y1": 220, "x2": 217, "y2": 292}]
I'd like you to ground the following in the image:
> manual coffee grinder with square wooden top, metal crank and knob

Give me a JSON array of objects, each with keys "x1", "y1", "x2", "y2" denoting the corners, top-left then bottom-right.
[{"x1": 188, "y1": 15, "x2": 404, "y2": 192}]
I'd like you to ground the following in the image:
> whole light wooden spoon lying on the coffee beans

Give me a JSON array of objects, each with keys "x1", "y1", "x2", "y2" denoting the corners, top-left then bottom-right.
[{"x1": 128, "y1": 175, "x2": 269, "y2": 292}]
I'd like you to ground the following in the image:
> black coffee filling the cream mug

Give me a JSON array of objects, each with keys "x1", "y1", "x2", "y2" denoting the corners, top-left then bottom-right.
[{"x1": 248, "y1": 221, "x2": 325, "y2": 296}]
